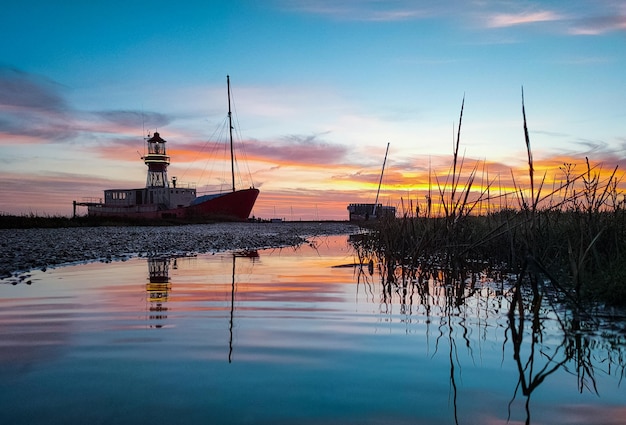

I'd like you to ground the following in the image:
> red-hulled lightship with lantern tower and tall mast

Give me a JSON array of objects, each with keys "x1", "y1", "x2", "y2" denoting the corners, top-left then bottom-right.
[{"x1": 74, "y1": 77, "x2": 259, "y2": 221}]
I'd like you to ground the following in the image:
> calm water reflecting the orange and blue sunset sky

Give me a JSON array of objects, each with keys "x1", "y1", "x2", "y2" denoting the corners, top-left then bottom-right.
[{"x1": 0, "y1": 236, "x2": 626, "y2": 425}]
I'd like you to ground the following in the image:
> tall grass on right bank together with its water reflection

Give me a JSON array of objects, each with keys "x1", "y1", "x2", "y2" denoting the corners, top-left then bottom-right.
[{"x1": 354, "y1": 90, "x2": 626, "y2": 424}]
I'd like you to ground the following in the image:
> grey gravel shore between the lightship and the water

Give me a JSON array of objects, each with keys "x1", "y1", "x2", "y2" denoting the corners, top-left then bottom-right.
[{"x1": 0, "y1": 222, "x2": 359, "y2": 279}]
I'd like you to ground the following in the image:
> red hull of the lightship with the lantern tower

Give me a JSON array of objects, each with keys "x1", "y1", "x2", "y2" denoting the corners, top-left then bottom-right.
[{"x1": 89, "y1": 189, "x2": 259, "y2": 221}]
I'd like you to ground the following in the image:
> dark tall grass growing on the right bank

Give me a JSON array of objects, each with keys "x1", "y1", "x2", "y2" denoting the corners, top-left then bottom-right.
[{"x1": 359, "y1": 94, "x2": 626, "y2": 305}]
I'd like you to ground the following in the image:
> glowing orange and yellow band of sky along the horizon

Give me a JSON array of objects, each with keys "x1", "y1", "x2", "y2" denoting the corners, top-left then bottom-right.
[{"x1": 3, "y1": 144, "x2": 626, "y2": 221}]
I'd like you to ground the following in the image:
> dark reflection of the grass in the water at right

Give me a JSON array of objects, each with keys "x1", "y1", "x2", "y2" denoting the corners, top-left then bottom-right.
[{"x1": 355, "y1": 243, "x2": 626, "y2": 424}]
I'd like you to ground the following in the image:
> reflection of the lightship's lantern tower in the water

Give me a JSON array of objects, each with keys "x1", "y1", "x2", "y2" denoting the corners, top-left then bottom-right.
[{"x1": 146, "y1": 257, "x2": 176, "y2": 328}]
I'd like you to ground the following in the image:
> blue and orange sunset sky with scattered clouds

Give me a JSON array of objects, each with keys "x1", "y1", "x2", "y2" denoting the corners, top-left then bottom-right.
[{"x1": 0, "y1": 0, "x2": 626, "y2": 220}]
